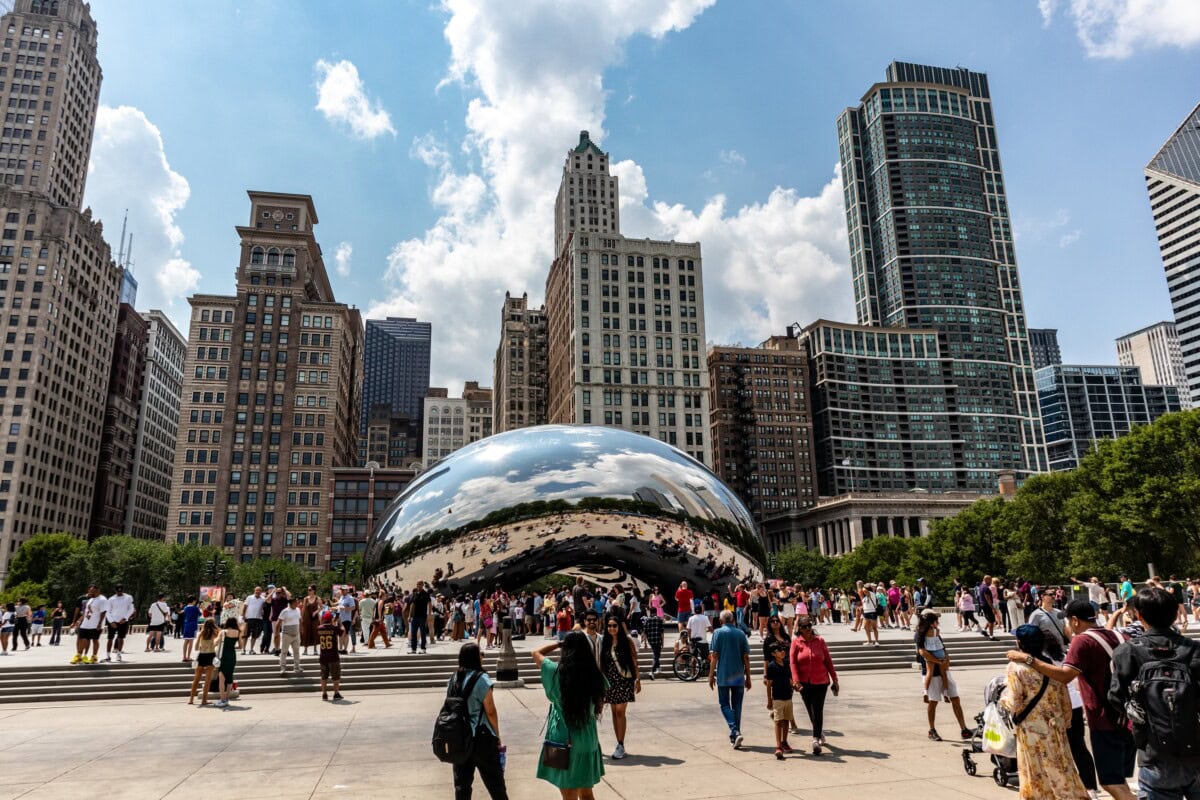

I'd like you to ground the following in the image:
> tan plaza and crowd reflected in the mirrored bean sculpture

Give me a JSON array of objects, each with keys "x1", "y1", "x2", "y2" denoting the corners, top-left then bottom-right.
[{"x1": 369, "y1": 511, "x2": 754, "y2": 588}]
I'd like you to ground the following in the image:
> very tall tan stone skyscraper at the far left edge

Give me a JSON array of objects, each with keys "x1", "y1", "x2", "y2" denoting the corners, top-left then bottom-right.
[{"x1": 0, "y1": 0, "x2": 121, "y2": 579}]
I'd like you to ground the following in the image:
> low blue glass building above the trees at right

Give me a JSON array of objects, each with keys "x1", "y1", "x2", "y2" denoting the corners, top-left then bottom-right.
[{"x1": 1038, "y1": 365, "x2": 1181, "y2": 470}]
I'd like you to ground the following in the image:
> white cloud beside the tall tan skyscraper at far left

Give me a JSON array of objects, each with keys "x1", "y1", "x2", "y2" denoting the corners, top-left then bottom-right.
[{"x1": 84, "y1": 106, "x2": 200, "y2": 331}]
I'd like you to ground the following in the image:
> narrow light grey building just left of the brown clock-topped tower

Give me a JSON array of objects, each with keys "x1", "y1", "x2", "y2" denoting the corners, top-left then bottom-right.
[{"x1": 125, "y1": 311, "x2": 187, "y2": 540}]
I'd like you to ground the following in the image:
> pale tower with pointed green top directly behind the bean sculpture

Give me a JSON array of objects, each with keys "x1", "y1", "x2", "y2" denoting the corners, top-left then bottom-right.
[{"x1": 546, "y1": 131, "x2": 713, "y2": 464}]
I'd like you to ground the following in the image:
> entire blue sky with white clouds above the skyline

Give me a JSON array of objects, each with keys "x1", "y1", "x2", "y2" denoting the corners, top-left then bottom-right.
[{"x1": 77, "y1": 0, "x2": 1200, "y2": 391}]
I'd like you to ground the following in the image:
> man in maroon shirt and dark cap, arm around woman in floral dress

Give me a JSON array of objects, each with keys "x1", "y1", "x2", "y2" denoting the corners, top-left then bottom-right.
[{"x1": 1008, "y1": 600, "x2": 1136, "y2": 800}]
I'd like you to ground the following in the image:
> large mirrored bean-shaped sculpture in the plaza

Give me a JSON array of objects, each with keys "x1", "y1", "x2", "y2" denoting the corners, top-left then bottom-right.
[{"x1": 364, "y1": 426, "x2": 766, "y2": 595}]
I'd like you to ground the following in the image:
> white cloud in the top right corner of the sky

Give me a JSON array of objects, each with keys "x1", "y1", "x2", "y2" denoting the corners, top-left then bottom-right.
[{"x1": 1038, "y1": 0, "x2": 1200, "y2": 59}]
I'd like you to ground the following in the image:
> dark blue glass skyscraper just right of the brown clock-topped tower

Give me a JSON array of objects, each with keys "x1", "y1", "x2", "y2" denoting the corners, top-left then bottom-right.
[{"x1": 359, "y1": 317, "x2": 433, "y2": 437}]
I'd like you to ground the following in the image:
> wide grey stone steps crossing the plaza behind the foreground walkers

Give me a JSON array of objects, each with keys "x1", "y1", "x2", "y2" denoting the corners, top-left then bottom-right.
[{"x1": 0, "y1": 632, "x2": 1200, "y2": 703}]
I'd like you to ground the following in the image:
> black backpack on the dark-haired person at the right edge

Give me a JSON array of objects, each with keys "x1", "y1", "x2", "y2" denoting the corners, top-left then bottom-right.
[{"x1": 1126, "y1": 639, "x2": 1200, "y2": 758}]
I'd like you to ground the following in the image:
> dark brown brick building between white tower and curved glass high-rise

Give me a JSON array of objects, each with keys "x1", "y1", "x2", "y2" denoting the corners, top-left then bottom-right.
[{"x1": 708, "y1": 336, "x2": 817, "y2": 524}]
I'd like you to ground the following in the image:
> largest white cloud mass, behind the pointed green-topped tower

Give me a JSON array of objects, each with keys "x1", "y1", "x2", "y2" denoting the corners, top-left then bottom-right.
[{"x1": 368, "y1": 0, "x2": 851, "y2": 387}]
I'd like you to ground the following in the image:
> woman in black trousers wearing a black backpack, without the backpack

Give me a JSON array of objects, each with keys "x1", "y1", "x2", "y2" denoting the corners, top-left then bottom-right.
[{"x1": 446, "y1": 642, "x2": 509, "y2": 800}]
